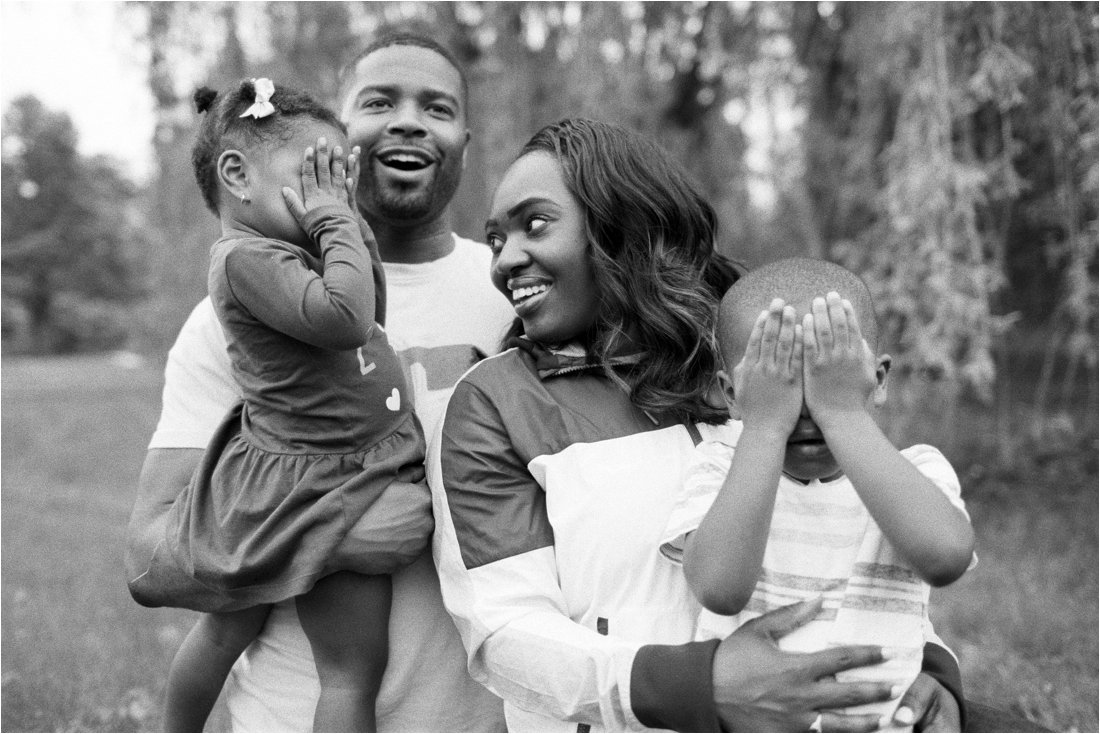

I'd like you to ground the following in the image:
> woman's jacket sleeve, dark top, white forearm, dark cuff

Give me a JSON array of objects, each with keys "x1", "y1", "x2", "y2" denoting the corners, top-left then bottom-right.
[{"x1": 428, "y1": 381, "x2": 718, "y2": 731}]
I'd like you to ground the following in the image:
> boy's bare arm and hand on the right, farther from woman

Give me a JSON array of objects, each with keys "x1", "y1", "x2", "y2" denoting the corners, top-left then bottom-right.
[{"x1": 802, "y1": 293, "x2": 974, "y2": 587}]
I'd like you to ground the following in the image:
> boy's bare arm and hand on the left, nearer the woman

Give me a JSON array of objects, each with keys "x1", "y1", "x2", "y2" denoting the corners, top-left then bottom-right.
[{"x1": 684, "y1": 299, "x2": 802, "y2": 614}]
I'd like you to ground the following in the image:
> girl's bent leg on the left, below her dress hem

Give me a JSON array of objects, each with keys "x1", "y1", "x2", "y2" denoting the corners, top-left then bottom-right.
[{"x1": 164, "y1": 604, "x2": 271, "y2": 732}]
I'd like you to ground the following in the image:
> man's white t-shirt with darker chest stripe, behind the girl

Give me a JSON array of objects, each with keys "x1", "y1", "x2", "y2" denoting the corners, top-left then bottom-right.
[{"x1": 150, "y1": 235, "x2": 515, "y2": 732}]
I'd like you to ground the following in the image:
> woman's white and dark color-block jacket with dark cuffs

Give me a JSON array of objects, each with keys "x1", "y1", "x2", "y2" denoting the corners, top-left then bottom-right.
[{"x1": 428, "y1": 339, "x2": 961, "y2": 732}]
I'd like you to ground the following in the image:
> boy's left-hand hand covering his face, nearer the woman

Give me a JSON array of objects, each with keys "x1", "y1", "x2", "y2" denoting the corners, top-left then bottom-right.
[{"x1": 733, "y1": 298, "x2": 803, "y2": 440}]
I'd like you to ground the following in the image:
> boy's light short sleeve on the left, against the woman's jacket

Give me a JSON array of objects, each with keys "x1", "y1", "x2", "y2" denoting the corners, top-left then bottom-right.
[{"x1": 660, "y1": 441, "x2": 734, "y2": 563}]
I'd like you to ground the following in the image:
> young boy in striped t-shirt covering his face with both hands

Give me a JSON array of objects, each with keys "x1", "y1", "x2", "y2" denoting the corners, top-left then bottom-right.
[{"x1": 661, "y1": 259, "x2": 974, "y2": 731}]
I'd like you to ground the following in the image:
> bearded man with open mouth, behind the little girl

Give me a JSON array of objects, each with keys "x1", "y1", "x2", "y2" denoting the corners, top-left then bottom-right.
[{"x1": 128, "y1": 32, "x2": 513, "y2": 732}]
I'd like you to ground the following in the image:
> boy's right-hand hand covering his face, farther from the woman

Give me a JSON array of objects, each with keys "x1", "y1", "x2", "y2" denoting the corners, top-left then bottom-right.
[{"x1": 802, "y1": 292, "x2": 877, "y2": 425}]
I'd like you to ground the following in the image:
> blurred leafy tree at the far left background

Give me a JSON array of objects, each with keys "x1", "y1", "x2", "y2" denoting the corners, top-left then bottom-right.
[{"x1": 2, "y1": 96, "x2": 144, "y2": 352}]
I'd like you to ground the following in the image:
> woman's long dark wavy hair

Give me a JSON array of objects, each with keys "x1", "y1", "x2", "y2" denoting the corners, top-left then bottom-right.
[{"x1": 517, "y1": 119, "x2": 737, "y2": 423}]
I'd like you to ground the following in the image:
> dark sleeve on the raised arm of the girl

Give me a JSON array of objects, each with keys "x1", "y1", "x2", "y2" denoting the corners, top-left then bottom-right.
[{"x1": 224, "y1": 207, "x2": 381, "y2": 350}]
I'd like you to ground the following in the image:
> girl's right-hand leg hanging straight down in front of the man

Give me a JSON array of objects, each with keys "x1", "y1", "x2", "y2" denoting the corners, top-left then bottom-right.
[{"x1": 295, "y1": 571, "x2": 392, "y2": 732}]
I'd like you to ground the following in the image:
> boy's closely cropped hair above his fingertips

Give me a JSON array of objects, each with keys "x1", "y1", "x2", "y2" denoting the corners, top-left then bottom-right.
[{"x1": 717, "y1": 258, "x2": 879, "y2": 369}]
